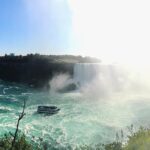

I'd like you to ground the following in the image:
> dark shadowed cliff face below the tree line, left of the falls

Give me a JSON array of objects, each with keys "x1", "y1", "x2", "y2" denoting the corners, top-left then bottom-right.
[{"x1": 0, "y1": 61, "x2": 74, "y2": 87}]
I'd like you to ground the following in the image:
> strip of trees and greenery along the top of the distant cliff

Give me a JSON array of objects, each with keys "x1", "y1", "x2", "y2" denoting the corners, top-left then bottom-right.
[{"x1": 0, "y1": 53, "x2": 100, "y2": 63}]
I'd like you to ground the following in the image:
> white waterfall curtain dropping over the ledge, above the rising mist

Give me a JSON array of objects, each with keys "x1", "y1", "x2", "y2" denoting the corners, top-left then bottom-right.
[{"x1": 74, "y1": 63, "x2": 120, "y2": 86}]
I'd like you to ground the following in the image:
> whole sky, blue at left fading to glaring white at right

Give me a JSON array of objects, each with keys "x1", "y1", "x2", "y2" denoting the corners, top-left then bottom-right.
[{"x1": 0, "y1": 0, "x2": 150, "y2": 64}]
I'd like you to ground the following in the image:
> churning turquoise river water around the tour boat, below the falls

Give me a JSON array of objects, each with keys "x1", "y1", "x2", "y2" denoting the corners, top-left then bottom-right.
[{"x1": 0, "y1": 81, "x2": 150, "y2": 148}]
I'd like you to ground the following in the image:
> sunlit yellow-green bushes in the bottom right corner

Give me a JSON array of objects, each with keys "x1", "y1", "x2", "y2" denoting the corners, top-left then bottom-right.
[{"x1": 76, "y1": 125, "x2": 150, "y2": 150}]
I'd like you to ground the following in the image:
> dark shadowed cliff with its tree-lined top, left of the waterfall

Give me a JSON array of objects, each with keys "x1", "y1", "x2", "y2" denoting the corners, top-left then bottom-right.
[{"x1": 0, "y1": 54, "x2": 100, "y2": 87}]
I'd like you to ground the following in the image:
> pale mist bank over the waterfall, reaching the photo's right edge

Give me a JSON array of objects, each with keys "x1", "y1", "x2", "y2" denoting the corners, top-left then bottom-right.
[{"x1": 74, "y1": 64, "x2": 150, "y2": 101}]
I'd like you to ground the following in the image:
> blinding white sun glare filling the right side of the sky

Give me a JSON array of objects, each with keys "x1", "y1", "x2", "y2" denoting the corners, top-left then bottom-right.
[{"x1": 69, "y1": 0, "x2": 150, "y2": 65}]
